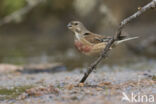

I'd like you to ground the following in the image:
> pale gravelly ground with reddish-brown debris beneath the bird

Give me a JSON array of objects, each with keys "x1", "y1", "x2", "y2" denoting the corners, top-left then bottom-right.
[{"x1": 0, "y1": 61, "x2": 156, "y2": 104}]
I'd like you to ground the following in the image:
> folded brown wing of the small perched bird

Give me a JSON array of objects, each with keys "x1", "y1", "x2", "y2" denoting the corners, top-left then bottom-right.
[{"x1": 84, "y1": 33, "x2": 111, "y2": 44}]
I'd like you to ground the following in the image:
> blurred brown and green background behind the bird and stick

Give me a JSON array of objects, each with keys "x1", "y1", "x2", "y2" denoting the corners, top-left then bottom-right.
[{"x1": 0, "y1": 0, "x2": 156, "y2": 69}]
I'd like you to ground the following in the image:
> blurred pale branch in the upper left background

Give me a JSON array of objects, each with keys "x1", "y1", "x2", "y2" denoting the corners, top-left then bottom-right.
[{"x1": 0, "y1": 0, "x2": 44, "y2": 26}]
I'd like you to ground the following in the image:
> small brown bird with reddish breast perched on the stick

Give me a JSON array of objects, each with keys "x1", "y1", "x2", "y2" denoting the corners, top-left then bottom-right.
[{"x1": 67, "y1": 21, "x2": 138, "y2": 56}]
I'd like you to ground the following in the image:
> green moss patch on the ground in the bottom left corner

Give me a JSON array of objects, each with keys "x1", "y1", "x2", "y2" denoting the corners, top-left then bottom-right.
[{"x1": 0, "y1": 86, "x2": 32, "y2": 100}]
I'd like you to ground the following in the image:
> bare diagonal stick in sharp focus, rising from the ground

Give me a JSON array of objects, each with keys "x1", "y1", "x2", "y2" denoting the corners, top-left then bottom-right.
[{"x1": 80, "y1": 0, "x2": 156, "y2": 83}]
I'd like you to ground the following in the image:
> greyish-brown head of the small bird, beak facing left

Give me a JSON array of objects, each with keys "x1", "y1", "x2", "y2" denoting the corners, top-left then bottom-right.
[{"x1": 67, "y1": 21, "x2": 88, "y2": 33}]
